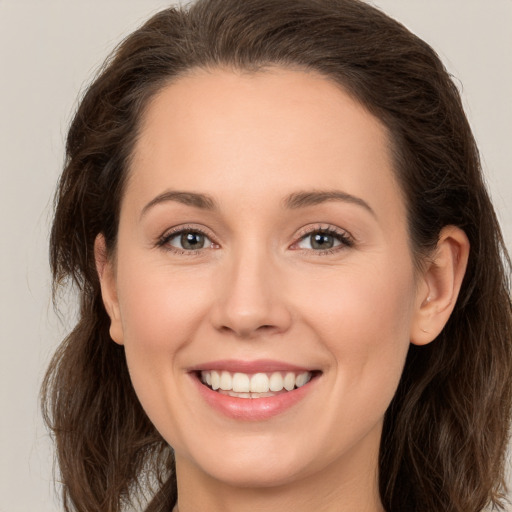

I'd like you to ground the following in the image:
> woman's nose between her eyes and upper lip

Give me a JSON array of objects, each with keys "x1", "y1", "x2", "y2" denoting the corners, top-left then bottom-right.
[{"x1": 212, "y1": 245, "x2": 292, "y2": 339}]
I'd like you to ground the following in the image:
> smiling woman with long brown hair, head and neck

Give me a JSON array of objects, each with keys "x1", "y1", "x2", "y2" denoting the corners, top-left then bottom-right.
[{"x1": 43, "y1": 0, "x2": 512, "y2": 512}]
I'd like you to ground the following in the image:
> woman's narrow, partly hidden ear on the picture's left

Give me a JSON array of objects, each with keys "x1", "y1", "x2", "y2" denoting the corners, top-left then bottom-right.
[{"x1": 94, "y1": 233, "x2": 123, "y2": 345}]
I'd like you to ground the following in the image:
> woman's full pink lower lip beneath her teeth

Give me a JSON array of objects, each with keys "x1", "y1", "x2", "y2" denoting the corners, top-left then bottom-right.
[{"x1": 190, "y1": 374, "x2": 318, "y2": 421}]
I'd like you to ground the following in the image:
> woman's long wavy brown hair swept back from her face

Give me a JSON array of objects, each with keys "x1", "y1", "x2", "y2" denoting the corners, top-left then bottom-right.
[{"x1": 42, "y1": 0, "x2": 512, "y2": 512}]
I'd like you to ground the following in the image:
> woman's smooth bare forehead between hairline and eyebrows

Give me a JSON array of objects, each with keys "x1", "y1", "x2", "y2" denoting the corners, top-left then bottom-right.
[{"x1": 127, "y1": 68, "x2": 403, "y2": 222}]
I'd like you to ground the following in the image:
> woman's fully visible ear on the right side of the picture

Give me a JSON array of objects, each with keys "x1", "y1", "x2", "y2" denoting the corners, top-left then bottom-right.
[{"x1": 410, "y1": 226, "x2": 469, "y2": 345}]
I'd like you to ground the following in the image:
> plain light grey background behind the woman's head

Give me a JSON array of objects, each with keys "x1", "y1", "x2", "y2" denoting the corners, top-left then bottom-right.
[{"x1": 0, "y1": 0, "x2": 512, "y2": 512}]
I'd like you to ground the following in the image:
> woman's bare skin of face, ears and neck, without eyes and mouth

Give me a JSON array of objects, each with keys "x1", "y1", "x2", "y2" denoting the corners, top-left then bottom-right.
[{"x1": 96, "y1": 68, "x2": 469, "y2": 512}]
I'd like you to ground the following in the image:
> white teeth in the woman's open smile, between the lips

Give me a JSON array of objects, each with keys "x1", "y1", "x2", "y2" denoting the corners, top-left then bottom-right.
[{"x1": 197, "y1": 370, "x2": 320, "y2": 398}]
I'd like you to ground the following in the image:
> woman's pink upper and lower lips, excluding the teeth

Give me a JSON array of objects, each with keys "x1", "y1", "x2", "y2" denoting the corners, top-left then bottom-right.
[{"x1": 189, "y1": 361, "x2": 318, "y2": 421}]
